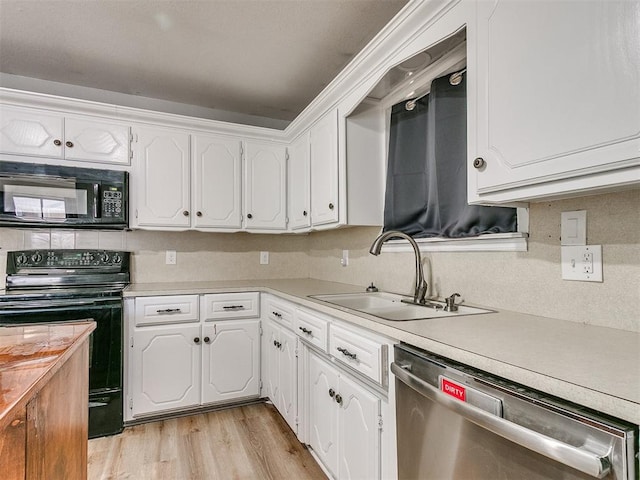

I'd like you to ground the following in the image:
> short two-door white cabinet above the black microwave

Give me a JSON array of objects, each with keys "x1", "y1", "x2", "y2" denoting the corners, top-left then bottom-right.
[{"x1": 0, "y1": 105, "x2": 131, "y2": 165}]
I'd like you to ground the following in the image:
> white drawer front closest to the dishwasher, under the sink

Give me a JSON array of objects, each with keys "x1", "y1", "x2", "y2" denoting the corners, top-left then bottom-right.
[{"x1": 329, "y1": 324, "x2": 387, "y2": 384}]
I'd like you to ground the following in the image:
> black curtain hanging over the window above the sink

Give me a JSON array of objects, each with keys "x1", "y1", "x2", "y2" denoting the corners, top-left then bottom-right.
[{"x1": 384, "y1": 75, "x2": 517, "y2": 238}]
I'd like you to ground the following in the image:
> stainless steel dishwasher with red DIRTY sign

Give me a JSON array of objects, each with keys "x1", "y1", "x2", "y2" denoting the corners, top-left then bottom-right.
[{"x1": 391, "y1": 344, "x2": 638, "y2": 480}]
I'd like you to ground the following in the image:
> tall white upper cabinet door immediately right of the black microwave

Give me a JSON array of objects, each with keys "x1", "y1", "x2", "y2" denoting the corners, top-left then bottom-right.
[{"x1": 132, "y1": 128, "x2": 191, "y2": 228}]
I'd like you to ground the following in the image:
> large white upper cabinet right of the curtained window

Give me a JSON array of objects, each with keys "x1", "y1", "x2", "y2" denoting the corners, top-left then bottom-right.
[{"x1": 469, "y1": 0, "x2": 640, "y2": 203}]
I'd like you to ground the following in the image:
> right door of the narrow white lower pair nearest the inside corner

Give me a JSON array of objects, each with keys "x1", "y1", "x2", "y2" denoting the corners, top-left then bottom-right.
[{"x1": 277, "y1": 328, "x2": 298, "y2": 433}]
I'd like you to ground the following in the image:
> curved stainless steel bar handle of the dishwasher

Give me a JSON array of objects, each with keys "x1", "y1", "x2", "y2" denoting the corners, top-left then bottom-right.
[{"x1": 391, "y1": 362, "x2": 611, "y2": 478}]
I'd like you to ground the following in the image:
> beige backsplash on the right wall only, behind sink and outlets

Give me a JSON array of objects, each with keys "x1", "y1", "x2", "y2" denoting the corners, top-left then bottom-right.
[{"x1": 309, "y1": 190, "x2": 640, "y2": 332}]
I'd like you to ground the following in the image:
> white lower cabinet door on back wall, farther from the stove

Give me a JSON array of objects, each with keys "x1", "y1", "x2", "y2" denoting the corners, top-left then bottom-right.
[{"x1": 202, "y1": 320, "x2": 260, "y2": 404}]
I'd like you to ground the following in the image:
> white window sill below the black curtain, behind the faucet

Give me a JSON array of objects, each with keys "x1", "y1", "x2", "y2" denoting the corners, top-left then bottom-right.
[{"x1": 382, "y1": 232, "x2": 529, "y2": 252}]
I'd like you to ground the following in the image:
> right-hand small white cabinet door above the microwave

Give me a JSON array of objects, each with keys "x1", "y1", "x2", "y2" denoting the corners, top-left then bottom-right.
[{"x1": 64, "y1": 118, "x2": 130, "y2": 165}]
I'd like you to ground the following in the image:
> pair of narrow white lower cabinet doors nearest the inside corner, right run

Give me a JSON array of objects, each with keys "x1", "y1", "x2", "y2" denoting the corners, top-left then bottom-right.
[{"x1": 264, "y1": 319, "x2": 298, "y2": 433}]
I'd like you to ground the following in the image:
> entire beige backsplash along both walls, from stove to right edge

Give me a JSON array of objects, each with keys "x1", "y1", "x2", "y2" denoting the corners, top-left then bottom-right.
[{"x1": 0, "y1": 190, "x2": 640, "y2": 332}]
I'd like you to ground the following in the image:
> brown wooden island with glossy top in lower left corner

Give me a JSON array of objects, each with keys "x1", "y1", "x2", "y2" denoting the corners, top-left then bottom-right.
[{"x1": 0, "y1": 322, "x2": 95, "y2": 480}]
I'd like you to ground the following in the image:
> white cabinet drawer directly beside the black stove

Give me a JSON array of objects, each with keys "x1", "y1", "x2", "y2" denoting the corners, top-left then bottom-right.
[{"x1": 136, "y1": 295, "x2": 198, "y2": 327}]
